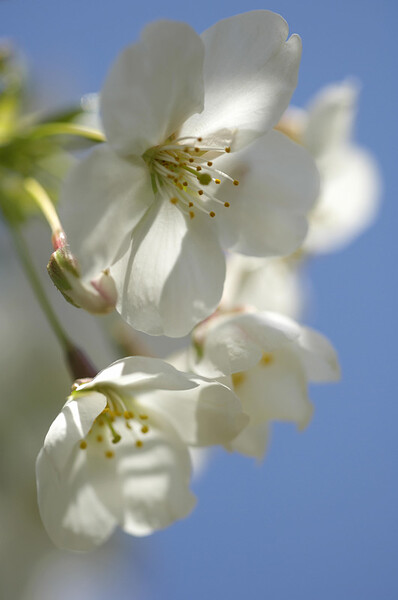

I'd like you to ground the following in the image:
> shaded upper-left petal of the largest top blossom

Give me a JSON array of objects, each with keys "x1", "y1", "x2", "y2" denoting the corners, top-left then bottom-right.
[{"x1": 101, "y1": 21, "x2": 204, "y2": 156}]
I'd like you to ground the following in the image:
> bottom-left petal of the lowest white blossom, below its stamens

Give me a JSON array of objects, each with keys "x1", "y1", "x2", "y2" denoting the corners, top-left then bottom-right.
[{"x1": 36, "y1": 444, "x2": 117, "y2": 551}]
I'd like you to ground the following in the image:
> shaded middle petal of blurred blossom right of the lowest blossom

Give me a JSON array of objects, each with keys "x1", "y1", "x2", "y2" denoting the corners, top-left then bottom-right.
[{"x1": 233, "y1": 348, "x2": 313, "y2": 429}]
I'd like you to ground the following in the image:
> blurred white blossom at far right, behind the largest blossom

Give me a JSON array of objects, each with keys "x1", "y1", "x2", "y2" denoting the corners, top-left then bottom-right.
[{"x1": 278, "y1": 80, "x2": 381, "y2": 253}]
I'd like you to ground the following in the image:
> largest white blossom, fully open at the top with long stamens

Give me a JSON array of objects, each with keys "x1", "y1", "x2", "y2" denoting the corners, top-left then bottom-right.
[{"x1": 63, "y1": 11, "x2": 319, "y2": 337}]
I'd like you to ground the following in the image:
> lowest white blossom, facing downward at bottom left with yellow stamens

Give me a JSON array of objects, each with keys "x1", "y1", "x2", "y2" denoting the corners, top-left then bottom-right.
[{"x1": 37, "y1": 357, "x2": 247, "y2": 550}]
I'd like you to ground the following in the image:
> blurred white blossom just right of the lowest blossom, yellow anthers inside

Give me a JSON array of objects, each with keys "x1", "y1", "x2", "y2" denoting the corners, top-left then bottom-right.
[{"x1": 188, "y1": 311, "x2": 340, "y2": 458}]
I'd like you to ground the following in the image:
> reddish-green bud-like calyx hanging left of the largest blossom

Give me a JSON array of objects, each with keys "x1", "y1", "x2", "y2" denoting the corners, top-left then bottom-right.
[{"x1": 47, "y1": 246, "x2": 117, "y2": 314}]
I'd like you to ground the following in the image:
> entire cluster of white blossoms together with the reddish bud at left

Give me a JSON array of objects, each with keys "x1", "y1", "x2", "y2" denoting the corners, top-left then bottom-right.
[{"x1": 0, "y1": 11, "x2": 378, "y2": 550}]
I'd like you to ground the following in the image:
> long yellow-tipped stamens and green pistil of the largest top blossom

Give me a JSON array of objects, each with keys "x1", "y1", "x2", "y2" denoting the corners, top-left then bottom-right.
[{"x1": 143, "y1": 136, "x2": 239, "y2": 219}]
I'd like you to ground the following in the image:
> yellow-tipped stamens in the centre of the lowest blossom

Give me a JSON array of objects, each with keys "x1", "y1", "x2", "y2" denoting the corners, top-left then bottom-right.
[{"x1": 79, "y1": 390, "x2": 150, "y2": 458}]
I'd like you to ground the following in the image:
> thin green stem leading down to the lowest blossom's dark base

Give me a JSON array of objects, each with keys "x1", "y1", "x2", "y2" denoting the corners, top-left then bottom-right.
[{"x1": 10, "y1": 226, "x2": 74, "y2": 353}]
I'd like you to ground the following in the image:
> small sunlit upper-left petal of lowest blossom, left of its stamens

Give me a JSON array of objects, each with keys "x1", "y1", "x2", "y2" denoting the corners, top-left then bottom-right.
[{"x1": 43, "y1": 391, "x2": 107, "y2": 472}]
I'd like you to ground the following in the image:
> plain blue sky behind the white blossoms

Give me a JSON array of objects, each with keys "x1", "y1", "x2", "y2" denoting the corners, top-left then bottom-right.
[{"x1": 0, "y1": 0, "x2": 398, "y2": 600}]
